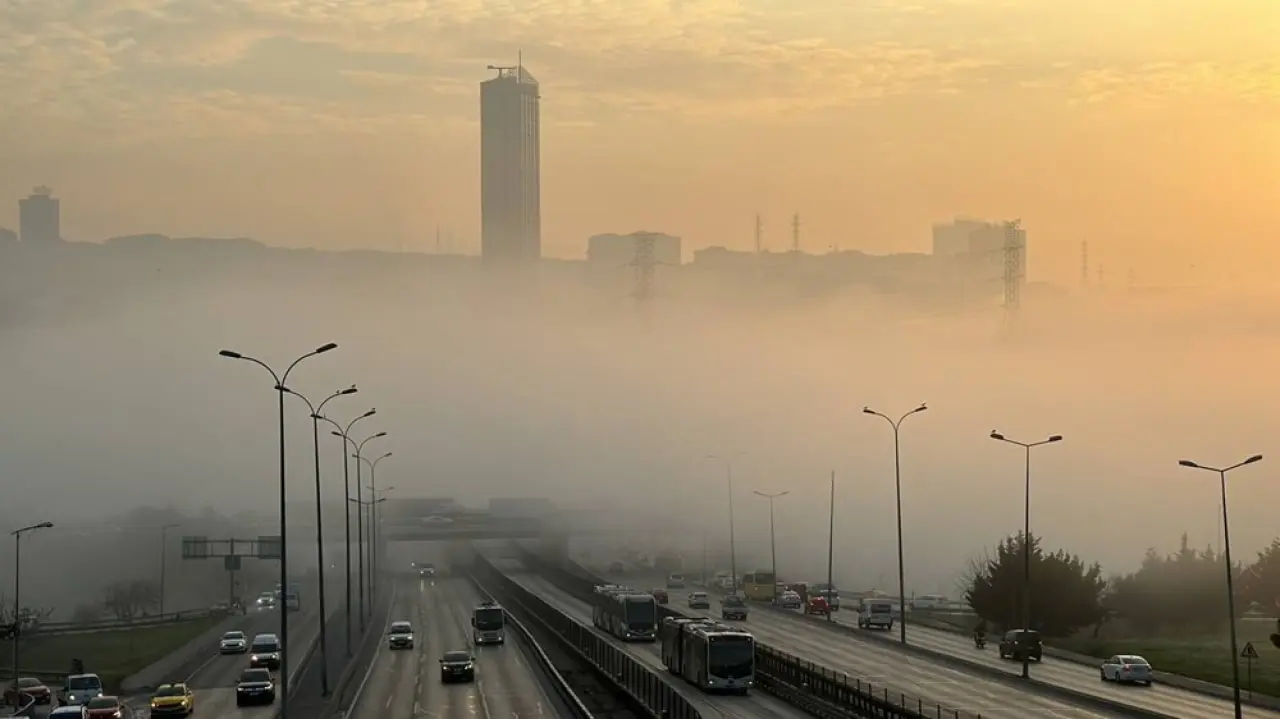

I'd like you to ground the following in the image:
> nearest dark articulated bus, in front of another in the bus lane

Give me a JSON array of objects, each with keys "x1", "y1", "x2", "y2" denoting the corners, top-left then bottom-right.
[{"x1": 658, "y1": 617, "x2": 755, "y2": 695}]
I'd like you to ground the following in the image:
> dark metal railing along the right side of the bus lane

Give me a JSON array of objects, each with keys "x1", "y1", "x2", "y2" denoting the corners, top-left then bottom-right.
[{"x1": 522, "y1": 549, "x2": 982, "y2": 719}]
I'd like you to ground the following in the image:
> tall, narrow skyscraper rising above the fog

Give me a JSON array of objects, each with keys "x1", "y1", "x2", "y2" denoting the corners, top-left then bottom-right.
[{"x1": 480, "y1": 60, "x2": 543, "y2": 264}]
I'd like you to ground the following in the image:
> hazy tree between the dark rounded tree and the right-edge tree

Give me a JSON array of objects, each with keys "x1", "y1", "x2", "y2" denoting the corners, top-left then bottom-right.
[{"x1": 1110, "y1": 533, "x2": 1244, "y2": 633}]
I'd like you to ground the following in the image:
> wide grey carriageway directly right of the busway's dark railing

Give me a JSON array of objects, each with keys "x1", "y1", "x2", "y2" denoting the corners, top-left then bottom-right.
[{"x1": 586, "y1": 577, "x2": 1126, "y2": 719}]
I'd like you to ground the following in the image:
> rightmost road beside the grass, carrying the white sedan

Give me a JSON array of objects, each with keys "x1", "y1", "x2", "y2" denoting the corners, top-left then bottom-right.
[{"x1": 819, "y1": 610, "x2": 1280, "y2": 719}]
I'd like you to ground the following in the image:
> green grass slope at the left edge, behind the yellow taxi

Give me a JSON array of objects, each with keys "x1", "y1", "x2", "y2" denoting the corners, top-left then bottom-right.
[{"x1": 0, "y1": 617, "x2": 221, "y2": 691}]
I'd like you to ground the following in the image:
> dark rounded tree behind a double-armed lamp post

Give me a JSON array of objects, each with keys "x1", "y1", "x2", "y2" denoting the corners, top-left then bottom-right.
[{"x1": 965, "y1": 532, "x2": 1107, "y2": 636}]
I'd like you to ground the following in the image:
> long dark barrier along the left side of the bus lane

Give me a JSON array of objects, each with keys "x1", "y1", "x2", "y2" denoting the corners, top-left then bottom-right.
[{"x1": 475, "y1": 554, "x2": 701, "y2": 719}]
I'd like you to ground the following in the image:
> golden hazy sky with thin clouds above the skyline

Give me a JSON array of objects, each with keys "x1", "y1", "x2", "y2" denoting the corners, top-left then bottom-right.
[{"x1": 0, "y1": 0, "x2": 1280, "y2": 281}]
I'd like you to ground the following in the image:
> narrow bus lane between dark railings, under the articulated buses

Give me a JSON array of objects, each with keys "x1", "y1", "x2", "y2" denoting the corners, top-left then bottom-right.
[{"x1": 493, "y1": 559, "x2": 809, "y2": 719}]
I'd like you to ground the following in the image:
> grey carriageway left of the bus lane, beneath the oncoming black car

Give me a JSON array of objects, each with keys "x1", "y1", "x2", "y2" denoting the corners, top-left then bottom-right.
[{"x1": 348, "y1": 577, "x2": 560, "y2": 719}]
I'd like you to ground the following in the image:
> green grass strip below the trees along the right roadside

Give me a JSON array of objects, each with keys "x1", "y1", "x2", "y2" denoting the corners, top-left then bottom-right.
[{"x1": 922, "y1": 615, "x2": 1280, "y2": 696}]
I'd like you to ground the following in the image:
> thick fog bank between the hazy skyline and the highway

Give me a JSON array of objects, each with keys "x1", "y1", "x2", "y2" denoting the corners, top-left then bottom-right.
[{"x1": 0, "y1": 256, "x2": 1280, "y2": 603}]
